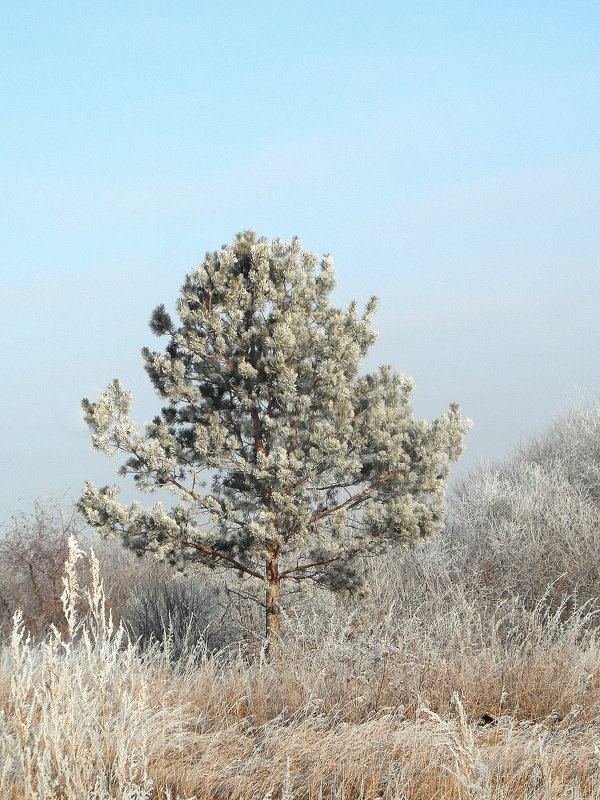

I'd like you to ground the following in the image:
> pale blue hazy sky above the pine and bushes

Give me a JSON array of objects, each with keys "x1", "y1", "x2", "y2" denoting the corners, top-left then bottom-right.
[{"x1": 0, "y1": 0, "x2": 600, "y2": 522}]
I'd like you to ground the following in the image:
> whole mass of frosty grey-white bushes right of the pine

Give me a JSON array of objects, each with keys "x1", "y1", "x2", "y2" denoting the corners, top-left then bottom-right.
[{"x1": 356, "y1": 404, "x2": 600, "y2": 621}]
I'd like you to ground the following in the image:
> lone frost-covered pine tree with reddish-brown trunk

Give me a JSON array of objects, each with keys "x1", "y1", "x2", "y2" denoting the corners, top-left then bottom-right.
[{"x1": 79, "y1": 232, "x2": 468, "y2": 639}]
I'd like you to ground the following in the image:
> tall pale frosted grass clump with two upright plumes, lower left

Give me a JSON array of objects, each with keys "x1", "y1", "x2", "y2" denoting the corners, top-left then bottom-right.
[{"x1": 0, "y1": 540, "x2": 196, "y2": 800}]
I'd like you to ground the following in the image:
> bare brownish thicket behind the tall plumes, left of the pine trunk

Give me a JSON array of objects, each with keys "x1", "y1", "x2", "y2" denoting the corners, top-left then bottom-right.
[{"x1": 0, "y1": 500, "x2": 254, "y2": 658}]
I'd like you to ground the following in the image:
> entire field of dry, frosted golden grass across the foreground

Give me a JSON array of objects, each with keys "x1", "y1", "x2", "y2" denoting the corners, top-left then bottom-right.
[{"x1": 0, "y1": 536, "x2": 600, "y2": 800}]
